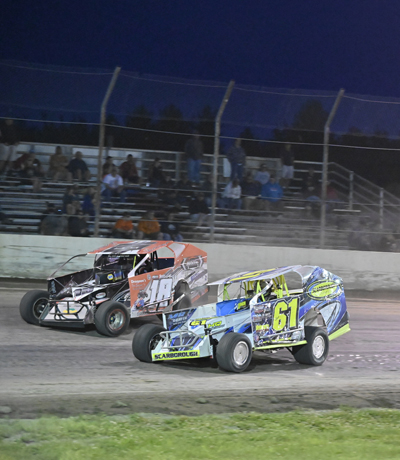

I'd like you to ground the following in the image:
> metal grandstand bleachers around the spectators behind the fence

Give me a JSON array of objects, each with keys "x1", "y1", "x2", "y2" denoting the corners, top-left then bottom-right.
[{"x1": 0, "y1": 144, "x2": 400, "y2": 249}]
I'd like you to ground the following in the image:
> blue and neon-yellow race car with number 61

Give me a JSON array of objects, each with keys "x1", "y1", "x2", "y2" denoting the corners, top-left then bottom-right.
[{"x1": 132, "y1": 265, "x2": 350, "y2": 372}]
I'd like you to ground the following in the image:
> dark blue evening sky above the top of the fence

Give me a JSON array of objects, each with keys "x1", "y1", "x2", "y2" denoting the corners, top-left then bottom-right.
[{"x1": 0, "y1": 0, "x2": 400, "y2": 97}]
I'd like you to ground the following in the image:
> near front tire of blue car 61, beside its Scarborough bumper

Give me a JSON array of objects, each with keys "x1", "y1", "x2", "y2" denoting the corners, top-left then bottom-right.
[{"x1": 216, "y1": 332, "x2": 252, "y2": 372}]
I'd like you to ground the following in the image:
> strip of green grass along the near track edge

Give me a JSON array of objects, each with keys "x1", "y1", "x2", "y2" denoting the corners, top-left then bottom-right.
[{"x1": 0, "y1": 408, "x2": 400, "y2": 460}]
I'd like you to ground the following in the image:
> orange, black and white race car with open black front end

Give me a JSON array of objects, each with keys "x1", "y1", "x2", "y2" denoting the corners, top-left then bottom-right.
[{"x1": 20, "y1": 241, "x2": 208, "y2": 336}]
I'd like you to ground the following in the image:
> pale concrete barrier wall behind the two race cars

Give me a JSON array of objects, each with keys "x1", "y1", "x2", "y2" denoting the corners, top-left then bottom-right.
[{"x1": 0, "y1": 234, "x2": 400, "y2": 291}]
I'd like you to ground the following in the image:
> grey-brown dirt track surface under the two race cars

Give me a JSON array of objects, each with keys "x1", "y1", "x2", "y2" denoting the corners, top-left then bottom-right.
[{"x1": 0, "y1": 281, "x2": 400, "y2": 418}]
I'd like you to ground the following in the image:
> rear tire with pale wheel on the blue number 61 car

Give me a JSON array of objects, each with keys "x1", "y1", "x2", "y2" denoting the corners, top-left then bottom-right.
[{"x1": 292, "y1": 326, "x2": 329, "y2": 366}]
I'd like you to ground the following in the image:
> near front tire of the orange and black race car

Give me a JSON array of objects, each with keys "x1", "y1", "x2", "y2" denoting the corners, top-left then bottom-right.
[{"x1": 94, "y1": 300, "x2": 130, "y2": 337}]
